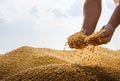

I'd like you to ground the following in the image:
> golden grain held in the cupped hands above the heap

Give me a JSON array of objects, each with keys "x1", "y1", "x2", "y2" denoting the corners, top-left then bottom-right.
[{"x1": 68, "y1": 31, "x2": 102, "y2": 49}]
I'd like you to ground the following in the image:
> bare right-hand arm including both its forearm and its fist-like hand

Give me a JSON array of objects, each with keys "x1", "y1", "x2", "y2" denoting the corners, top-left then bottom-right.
[{"x1": 100, "y1": 4, "x2": 120, "y2": 44}]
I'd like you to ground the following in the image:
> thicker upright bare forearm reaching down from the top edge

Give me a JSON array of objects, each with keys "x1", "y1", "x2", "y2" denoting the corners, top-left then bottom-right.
[{"x1": 82, "y1": 0, "x2": 101, "y2": 35}]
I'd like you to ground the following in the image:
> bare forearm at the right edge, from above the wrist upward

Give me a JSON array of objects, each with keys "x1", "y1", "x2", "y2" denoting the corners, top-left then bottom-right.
[{"x1": 108, "y1": 4, "x2": 120, "y2": 28}]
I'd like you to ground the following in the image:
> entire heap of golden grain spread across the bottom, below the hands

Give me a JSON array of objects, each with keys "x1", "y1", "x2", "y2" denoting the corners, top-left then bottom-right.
[{"x1": 0, "y1": 46, "x2": 120, "y2": 81}]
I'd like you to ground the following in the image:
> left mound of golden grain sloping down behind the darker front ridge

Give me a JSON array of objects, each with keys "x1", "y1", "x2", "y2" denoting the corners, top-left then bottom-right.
[{"x1": 0, "y1": 47, "x2": 67, "y2": 79}]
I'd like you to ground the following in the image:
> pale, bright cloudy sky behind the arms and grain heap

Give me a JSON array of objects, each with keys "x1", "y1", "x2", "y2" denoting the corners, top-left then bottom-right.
[{"x1": 0, "y1": 0, "x2": 120, "y2": 54}]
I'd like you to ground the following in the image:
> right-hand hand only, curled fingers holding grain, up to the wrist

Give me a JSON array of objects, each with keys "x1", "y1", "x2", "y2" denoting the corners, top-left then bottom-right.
[{"x1": 100, "y1": 24, "x2": 115, "y2": 44}]
